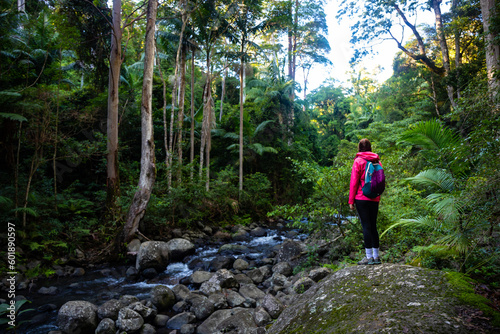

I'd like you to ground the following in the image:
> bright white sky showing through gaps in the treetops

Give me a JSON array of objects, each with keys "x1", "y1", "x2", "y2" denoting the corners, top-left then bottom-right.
[{"x1": 299, "y1": 0, "x2": 445, "y2": 92}]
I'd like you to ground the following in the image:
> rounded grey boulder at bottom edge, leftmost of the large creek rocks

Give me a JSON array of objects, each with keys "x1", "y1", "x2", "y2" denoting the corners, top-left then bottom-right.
[{"x1": 57, "y1": 300, "x2": 98, "y2": 334}]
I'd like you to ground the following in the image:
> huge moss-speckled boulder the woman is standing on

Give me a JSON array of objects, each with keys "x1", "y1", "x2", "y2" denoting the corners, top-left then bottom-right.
[{"x1": 268, "y1": 264, "x2": 498, "y2": 334}]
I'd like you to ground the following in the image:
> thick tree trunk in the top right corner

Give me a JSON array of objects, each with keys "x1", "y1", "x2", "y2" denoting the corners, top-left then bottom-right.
[{"x1": 481, "y1": 0, "x2": 500, "y2": 97}]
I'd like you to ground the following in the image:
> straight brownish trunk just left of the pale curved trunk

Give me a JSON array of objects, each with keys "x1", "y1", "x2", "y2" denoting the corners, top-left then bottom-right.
[{"x1": 106, "y1": 0, "x2": 122, "y2": 221}]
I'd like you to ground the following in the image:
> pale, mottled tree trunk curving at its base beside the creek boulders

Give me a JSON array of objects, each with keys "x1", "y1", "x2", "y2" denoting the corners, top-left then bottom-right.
[{"x1": 123, "y1": 0, "x2": 158, "y2": 242}]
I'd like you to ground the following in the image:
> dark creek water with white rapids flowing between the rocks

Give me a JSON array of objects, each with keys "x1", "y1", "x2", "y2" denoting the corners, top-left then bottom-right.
[{"x1": 16, "y1": 230, "x2": 306, "y2": 334}]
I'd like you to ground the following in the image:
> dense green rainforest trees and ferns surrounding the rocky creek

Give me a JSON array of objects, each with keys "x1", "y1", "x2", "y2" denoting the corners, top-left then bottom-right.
[{"x1": 0, "y1": 0, "x2": 500, "y2": 332}]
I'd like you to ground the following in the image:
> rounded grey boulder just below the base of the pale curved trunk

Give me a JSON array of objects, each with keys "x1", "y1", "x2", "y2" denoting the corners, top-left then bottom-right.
[{"x1": 135, "y1": 241, "x2": 170, "y2": 271}]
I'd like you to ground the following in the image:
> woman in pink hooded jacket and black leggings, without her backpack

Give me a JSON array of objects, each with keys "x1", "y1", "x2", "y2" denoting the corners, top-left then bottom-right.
[{"x1": 349, "y1": 138, "x2": 381, "y2": 265}]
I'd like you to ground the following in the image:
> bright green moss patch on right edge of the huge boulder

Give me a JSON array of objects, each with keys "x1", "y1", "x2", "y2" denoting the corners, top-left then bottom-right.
[{"x1": 445, "y1": 272, "x2": 500, "y2": 327}]
